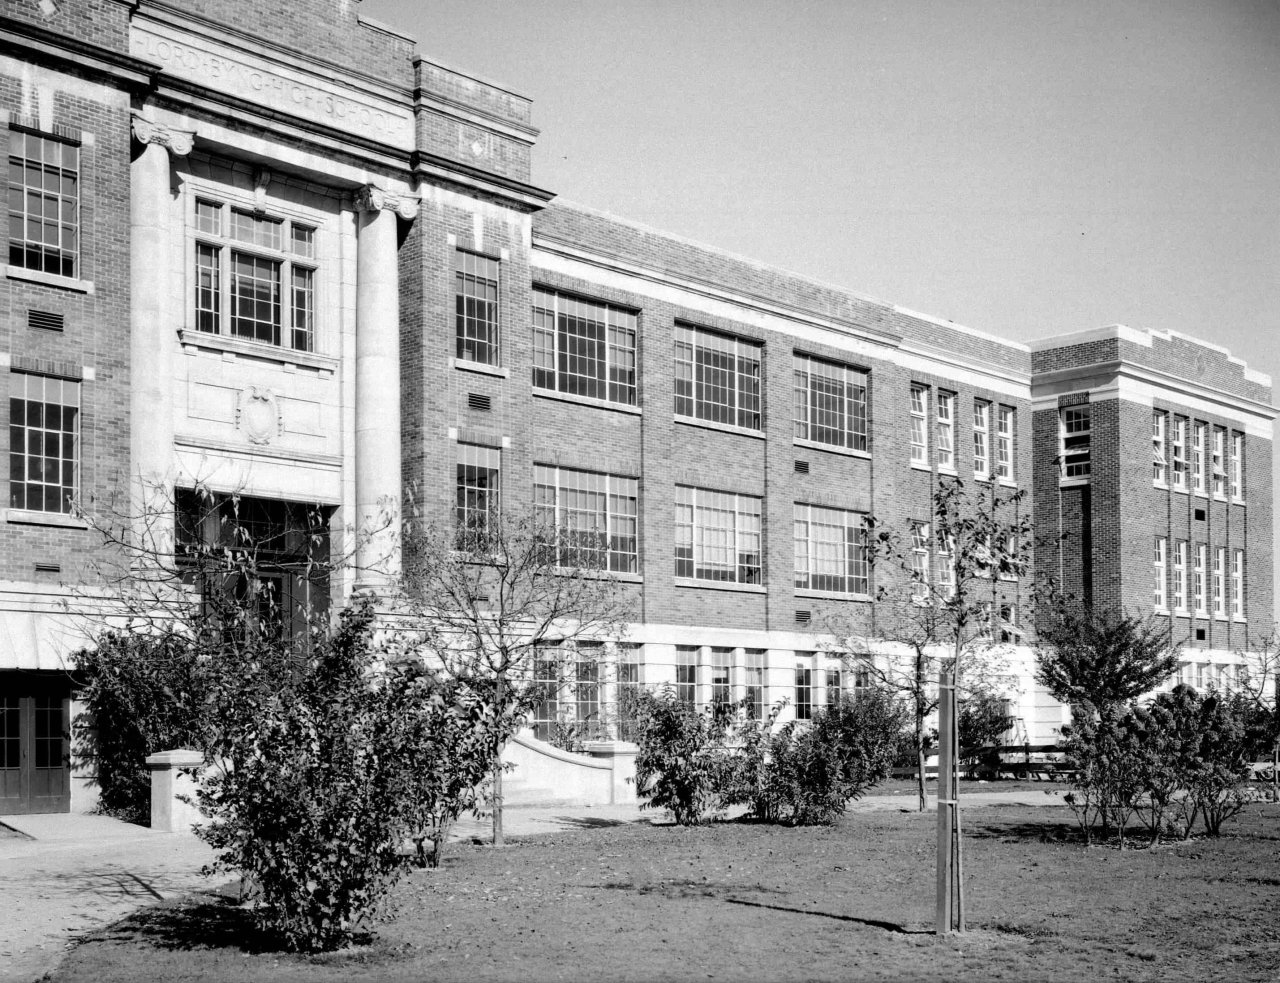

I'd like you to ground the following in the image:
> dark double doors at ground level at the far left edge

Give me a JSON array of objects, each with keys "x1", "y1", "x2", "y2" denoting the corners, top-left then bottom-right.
[{"x1": 0, "y1": 673, "x2": 72, "y2": 815}]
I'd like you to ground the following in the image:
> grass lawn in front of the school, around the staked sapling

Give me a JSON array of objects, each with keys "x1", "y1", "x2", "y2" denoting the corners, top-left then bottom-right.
[{"x1": 51, "y1": 805, "x2": 1280, "y2": 983}]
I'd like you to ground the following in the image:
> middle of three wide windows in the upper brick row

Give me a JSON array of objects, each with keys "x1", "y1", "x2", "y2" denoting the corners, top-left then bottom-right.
[{"x1": 676, "y1": 324, "x2": 760, "y2": 430}]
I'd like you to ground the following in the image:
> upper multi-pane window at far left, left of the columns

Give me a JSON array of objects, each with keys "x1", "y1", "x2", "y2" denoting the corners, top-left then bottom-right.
[{"x1": 9, "y1": 129, "x2": 79, "y2": 276}]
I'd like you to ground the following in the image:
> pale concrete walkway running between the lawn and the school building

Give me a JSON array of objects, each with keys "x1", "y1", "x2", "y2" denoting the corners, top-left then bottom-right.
[{"x1": 0, "y1": 787, "x2": 1065, "y2": 983}]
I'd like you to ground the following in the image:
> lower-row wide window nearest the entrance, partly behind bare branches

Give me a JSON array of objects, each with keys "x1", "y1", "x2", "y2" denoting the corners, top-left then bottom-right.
[{"x1": 534, "y1": 465, "x2": 639, "y2": 573}]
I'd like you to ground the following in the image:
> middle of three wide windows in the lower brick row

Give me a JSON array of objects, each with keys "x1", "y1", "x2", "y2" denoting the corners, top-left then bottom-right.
[{"x1": 676, "y1": 485, "x2": 762, "y2": 584}]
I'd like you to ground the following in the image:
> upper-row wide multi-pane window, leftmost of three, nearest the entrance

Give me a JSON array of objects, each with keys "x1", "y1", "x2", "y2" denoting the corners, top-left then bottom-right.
[{"x1": 534, "y1": 287, "x2": 636, "y2": 406}]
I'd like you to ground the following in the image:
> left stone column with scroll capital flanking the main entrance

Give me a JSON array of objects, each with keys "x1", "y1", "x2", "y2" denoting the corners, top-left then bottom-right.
[{"x1": 129, "y1": 115, "x2": 195, "y2": 555}]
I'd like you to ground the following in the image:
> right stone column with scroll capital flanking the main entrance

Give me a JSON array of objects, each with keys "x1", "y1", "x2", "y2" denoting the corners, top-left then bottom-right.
[{"x1": 353, "y1": 184, "x2": 417, "y2": 593}]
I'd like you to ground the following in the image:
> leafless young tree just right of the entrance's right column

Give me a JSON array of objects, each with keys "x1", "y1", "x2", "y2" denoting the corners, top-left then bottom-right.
[{"x1": 404, "y1": 509, "x2": 631, "y2": 846}]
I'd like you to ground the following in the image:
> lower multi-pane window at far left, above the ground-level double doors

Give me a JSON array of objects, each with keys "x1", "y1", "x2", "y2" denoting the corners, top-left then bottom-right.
[{"x1": 9, "y1": 372, "x2": 81, "y2": 513}]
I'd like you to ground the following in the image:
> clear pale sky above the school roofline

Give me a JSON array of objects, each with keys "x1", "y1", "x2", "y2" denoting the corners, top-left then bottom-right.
[{"x1": 361, "y1": 0, "x2": 1280, "y2": 606}]
